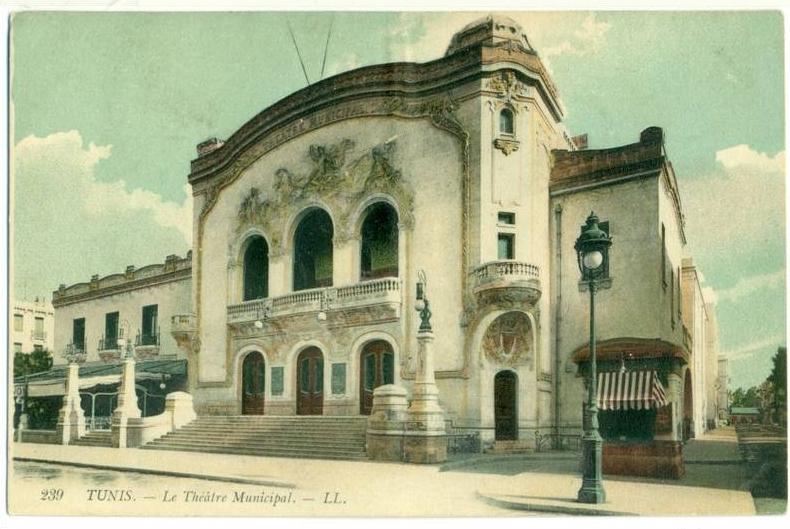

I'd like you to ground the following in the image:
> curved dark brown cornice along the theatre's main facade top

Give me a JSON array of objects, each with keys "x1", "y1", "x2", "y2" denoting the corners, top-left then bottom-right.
[{"x1": 189, "y1": 46, "x2": 563, "y2": 188}]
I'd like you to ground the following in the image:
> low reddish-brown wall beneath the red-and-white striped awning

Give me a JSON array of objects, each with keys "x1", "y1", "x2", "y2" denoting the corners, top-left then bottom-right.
[{"x1": 602, "y1": 441, "x2": 686, "y2": 479}]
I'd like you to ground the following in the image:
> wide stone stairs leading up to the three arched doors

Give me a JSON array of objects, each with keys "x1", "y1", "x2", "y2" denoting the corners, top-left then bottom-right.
[{"x1": 142, "y1": 415, "x2": 367, "y2": 460}]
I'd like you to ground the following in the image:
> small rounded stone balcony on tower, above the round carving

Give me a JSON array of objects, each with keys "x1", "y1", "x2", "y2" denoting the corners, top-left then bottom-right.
[{"x1": 471, "y1": 260, "x2": 541, "y2": 308}]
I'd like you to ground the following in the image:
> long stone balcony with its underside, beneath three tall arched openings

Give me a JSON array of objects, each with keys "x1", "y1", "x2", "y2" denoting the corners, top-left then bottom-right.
[{"x1": 228, "y1": 277, "x2": 401, "y2": 326}]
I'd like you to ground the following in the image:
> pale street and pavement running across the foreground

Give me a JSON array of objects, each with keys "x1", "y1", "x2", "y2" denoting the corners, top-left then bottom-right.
[{"x1": 9, "y1": 424, "x2": 755, "y2": 517}]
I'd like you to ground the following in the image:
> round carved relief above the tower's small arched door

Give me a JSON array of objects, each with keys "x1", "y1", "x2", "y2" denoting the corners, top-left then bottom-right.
[{"x1": 483, "y1": 312, "x2": 532, "y2": 365}]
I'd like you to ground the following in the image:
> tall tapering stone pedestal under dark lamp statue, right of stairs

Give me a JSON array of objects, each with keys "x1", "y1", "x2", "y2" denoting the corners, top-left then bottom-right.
[{"x1": 403, "y1": 330, "x2": 447, "y2": 463}]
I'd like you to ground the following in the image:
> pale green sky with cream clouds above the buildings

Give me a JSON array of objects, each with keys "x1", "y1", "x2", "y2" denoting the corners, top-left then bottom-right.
[{"x1": 10, "y1": 7, "x2": 786, "y2": 388}]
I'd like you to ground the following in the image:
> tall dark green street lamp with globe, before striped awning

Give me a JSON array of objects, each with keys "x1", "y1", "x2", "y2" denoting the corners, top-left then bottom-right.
[{"x1": 574, "y1": 212, "x2": 612, "y2": 503}]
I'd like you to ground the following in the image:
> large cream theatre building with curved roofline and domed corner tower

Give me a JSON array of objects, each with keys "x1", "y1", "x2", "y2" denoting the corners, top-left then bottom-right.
[{"x1": 21, "y1": 16, "x2": 720, "y2": 474}]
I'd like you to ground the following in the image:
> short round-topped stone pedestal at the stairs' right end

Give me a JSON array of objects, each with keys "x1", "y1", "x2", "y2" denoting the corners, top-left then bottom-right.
[{"x1": 367, "y1": 384, "x2": 408, "y2": 461}]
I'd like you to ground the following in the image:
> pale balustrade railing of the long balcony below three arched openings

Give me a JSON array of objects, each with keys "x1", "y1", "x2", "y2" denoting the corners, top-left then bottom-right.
[{"x1": 228, "y1": 277, "x2": 401, "y2": 323}]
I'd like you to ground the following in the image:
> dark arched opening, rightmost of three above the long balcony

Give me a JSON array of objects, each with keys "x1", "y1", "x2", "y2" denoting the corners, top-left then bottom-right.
[{"x1": 360, "y1": 202, "x2": 398, "y2": 279}]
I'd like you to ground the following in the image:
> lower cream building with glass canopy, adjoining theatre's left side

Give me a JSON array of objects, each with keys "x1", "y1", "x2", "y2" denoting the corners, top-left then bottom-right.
[{"x1": 15, "y1": 254, "x2": 192, "y2": 429}]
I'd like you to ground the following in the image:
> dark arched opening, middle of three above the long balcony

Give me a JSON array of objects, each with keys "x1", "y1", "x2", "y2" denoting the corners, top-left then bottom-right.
[{"x1": 293, "y1": 208, "x2": 334, "y2": 290}]
